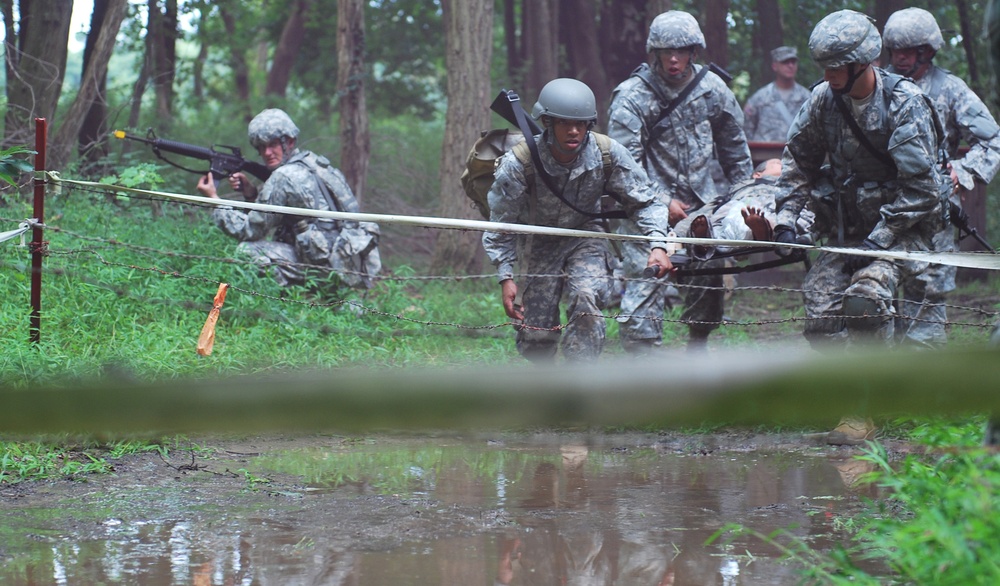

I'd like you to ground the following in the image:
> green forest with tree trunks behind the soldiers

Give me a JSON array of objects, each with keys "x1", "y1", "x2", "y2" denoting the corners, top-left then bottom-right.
[{"x1": 0, "y1": 0, "x2": 998, "y2": 274}]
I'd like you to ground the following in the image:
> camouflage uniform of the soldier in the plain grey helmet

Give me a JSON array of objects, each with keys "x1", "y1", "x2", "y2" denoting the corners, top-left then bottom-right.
[{"x1": 483, "y1": 131, "x2": 667, "y2": 361}]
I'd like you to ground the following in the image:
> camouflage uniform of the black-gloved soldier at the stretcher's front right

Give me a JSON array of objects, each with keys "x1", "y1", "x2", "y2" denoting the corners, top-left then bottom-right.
[{"x1": 777, "y1": 66, "x2": 945, "y2": 345}]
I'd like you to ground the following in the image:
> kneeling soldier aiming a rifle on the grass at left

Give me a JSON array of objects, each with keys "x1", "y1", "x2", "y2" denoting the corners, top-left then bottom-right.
[{"x1": 197, "y1": 108, "x2": 382, "y2": 288}]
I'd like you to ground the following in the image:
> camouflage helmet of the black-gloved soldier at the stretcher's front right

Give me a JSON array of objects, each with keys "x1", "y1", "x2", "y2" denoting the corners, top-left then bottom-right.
[{"x1": 809, "y1": 10, "x2": 882, "y2": 69}]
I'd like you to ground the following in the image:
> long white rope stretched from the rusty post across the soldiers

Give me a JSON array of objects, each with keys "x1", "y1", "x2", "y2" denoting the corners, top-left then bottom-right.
[{"x1": 46, "y1": 171, "x2": 1000, "y2": 270}]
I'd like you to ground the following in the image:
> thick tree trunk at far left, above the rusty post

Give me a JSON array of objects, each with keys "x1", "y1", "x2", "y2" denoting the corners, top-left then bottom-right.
[{"x1": 3, "y1": 0, "x2": 73, "y2": 146}]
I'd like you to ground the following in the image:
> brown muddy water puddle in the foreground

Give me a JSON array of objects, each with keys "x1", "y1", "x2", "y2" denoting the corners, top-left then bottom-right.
[{"x1": 0, "y1": 434, "x2": 876, "y2": 586}]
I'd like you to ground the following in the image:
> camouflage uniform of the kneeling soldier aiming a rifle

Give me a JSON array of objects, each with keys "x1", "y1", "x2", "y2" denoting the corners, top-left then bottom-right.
[{"x1": 212, "y1": 149, "x2": 381, "y2": 287}]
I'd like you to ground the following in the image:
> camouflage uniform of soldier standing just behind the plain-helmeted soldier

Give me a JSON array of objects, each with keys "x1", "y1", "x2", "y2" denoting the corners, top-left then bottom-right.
[{"x1": 608, "y1": 38, "x2": 753, "y2": 348}]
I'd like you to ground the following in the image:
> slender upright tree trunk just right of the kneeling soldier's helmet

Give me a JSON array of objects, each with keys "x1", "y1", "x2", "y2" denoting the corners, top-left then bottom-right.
[{"x1": 337, "y1": 0, "x2": 371, "y2": 203}]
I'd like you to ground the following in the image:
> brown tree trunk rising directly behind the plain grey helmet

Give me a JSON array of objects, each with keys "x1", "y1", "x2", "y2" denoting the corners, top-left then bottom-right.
[{"x1": 559, "y1": 0, "x2": 613, "y2": 128}]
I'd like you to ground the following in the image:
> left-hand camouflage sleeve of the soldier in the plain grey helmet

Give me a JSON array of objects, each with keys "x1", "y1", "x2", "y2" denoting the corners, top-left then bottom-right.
[{"x1": 483, "y1": 151, "x2": 528, "y2": 281}]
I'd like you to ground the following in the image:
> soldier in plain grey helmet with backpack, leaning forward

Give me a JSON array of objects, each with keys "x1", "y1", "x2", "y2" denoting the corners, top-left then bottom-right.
[{"x1": 483, "y1": 78, "x2": 672, "y2": 361}]
